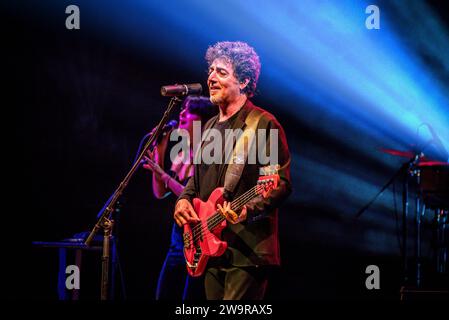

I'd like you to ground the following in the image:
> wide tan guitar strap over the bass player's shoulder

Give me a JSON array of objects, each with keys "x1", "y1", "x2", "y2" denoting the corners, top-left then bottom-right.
[{"x1": 224, "y1": 109, "x2": 263, "y2": 198}]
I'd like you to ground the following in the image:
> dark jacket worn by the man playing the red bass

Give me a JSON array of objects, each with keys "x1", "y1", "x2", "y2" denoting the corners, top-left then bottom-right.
[{"x1": 178, "y1": 100, "x2": 291, "y2": 266}]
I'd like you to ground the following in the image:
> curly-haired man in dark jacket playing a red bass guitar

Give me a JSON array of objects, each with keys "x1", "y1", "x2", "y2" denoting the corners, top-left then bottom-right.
[{"x1": 174, "y1": 42, "x2": 291, "y2": 300}]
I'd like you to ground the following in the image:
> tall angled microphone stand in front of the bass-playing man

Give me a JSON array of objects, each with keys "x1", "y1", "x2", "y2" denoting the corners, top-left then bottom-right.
[{"x1": 84, "y1": 96, "x2": 182, "y2": 300}]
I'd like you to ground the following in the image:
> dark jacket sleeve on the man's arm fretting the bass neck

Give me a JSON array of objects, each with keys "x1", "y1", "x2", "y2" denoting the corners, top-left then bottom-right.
[{"x1": 246, "y1": 116, "x2": 292, "y2": 223}]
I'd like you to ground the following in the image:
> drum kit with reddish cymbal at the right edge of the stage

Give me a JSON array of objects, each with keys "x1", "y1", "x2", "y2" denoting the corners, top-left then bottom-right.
[{"x1": 380, "y1": 149, "x2": 449, "y2": 287}]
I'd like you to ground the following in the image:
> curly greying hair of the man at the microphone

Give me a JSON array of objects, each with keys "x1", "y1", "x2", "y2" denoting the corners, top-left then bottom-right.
[{"x1": 206, "y1": 41, "x2": 260, "y2": 97}]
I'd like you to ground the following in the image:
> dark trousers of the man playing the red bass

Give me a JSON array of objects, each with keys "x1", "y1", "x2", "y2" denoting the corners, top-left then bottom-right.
[{"x1": 204, "y1": 266, "x2": 269, "y2": 300}]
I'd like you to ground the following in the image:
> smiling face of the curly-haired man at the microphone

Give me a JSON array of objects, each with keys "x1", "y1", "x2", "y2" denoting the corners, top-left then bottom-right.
[{"x1": 207, "y1": 58, "x2": 241, "y2": 106}]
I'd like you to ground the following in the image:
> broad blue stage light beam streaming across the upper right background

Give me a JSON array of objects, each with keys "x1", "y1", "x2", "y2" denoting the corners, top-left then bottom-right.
[{"x1": 31, "y1": 0, "x2": 449, "y2": 255}]
